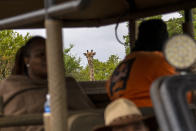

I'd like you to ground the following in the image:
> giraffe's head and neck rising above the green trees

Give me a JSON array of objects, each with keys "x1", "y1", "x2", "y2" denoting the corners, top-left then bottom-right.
[{"x1": 84, "y1": 50, "x2": 96, "y2": 81}]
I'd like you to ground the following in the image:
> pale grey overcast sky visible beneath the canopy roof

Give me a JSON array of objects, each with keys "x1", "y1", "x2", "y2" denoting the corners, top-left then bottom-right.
[{"x1": 15, "y1": 13, "x2": 180, "y2": 66}]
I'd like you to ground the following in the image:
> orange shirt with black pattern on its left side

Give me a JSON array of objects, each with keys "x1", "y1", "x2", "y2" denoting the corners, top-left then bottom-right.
[{"x1": 106, "y1": 51, "x2": 176, "y2": 107}]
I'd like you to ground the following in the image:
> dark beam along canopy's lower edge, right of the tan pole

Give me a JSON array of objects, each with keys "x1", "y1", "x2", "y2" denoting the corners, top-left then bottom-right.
[{"x1": 44, "y1": 1, "x2": 196, "y2": 27}]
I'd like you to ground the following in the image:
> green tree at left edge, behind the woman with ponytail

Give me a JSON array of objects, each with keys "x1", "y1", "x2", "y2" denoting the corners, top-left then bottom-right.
[{"x1": 0, "y1": 30, "x2": 30, "y2": 80}]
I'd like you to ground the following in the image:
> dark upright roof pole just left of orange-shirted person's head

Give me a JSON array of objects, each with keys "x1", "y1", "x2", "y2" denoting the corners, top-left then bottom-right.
[{"x1": 129, "y1": 19, "x2": 136, "y2": 52}]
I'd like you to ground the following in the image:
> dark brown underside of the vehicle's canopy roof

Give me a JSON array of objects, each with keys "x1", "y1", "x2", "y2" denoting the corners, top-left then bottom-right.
[{"x1": 0, "y1": 0, "x2": 196, "y2": 29}]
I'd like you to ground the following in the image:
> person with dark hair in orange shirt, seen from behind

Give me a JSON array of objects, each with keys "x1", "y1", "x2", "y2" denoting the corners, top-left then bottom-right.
[{"x1": 106, "y1": 19, "x2": 176, "y2": 107}]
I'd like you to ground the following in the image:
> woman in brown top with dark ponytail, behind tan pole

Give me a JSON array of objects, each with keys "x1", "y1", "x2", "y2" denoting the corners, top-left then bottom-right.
[{"x1": 0, "y1": 36, "x2": 93, "y2": 131}]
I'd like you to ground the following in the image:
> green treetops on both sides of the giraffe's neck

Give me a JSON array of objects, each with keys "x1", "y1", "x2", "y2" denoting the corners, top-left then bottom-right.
[{"x1": 64, "y1": 44, "x2": 120, "y2": 81}]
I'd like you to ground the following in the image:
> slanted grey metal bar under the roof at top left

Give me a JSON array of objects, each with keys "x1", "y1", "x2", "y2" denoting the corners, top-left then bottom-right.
[{"x1": 0, "y1": 0, "x2": 88, "y2": 29}]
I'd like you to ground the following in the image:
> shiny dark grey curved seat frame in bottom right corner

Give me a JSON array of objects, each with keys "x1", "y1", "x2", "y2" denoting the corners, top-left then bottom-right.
[{"x1": 151, "y1": 74, "x2": 196, "y2": 131}]
